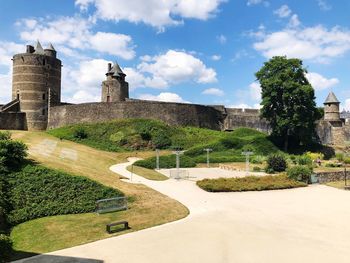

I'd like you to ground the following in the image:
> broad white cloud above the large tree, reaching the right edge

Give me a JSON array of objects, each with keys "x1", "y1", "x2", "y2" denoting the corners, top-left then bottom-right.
[{"x1": 254, "y1": 26, "x2": 350, "y2": 62}]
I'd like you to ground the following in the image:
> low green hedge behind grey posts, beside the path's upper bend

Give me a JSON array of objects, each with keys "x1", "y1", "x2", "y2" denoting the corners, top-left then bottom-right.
[{"x1": 134, "y1": 154, "x2": 196, "y2": 169}]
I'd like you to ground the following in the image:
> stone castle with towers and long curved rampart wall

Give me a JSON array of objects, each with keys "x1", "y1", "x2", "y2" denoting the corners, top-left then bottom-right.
[{"x1": 0, "y1": 41, "x2": 350, "y2": 144}]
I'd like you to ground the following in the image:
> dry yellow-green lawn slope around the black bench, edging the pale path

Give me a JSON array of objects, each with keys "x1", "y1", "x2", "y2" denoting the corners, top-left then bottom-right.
[{"x1": 11, "y1": 131, "x2": 188, "y2": 258}]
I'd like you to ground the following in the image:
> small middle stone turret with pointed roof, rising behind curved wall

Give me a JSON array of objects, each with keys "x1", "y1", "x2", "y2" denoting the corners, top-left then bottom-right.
[{"x1": 102, "y1": 62, "x2": 129, "y2": 102}]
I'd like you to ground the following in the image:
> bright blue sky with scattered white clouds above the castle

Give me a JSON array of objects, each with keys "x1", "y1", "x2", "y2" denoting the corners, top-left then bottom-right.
[{"x1": 0, "y1": 0, "x2": 350, "y2": 110}]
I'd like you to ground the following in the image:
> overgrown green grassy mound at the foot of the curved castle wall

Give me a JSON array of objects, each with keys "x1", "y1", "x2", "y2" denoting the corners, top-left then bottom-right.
[{"x1": 48, "y1": 119, "x2": 278, "y2": 168}]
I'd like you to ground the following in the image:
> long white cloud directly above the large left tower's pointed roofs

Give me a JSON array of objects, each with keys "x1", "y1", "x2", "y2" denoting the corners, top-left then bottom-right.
[{"x1": 16, "y1": 17, "x2": 135, "y2": 59}]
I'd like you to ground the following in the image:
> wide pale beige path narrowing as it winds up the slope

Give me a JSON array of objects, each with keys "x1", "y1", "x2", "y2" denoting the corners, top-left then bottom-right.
[{"x1": 15, "y1": 159, "x2": 350, "y2": 263}]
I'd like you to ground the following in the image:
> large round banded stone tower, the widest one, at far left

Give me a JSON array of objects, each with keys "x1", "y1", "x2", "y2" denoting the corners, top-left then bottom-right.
[{"x1": 12, "y1": 41, "x2": 62, "y2": 130}]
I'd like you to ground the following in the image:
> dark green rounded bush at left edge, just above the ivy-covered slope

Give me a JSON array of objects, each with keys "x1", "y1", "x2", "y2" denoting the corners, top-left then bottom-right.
[{"x1": 0, "y1": 140, "x2": 27, "y2": 167}]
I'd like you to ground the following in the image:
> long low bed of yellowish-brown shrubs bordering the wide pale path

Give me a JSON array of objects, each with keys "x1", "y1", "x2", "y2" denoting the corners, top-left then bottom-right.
[{"x1": 197, "y1": 175, "x2": 307, "y2": 192}]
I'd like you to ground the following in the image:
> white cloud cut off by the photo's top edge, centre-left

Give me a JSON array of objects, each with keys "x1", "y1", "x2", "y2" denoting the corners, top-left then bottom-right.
[{"x1": 75, "y1": 0, "x2": 226, "y2": 29}]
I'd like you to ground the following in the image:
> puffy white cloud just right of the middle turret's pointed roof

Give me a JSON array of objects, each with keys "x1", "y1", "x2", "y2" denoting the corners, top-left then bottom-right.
[{"x1": 125, "y1": 50, "x2": 217, "y2": 88}]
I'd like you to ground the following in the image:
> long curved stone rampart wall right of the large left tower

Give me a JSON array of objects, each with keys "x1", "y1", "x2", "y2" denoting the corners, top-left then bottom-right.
[{"x1": 48, "y1": 100, "x2": 224, "y2": 130}]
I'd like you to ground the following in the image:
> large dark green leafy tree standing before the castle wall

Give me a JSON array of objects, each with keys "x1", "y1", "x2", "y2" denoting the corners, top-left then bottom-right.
[{"x1": 255, "y1": 56, "x2": 320, "y2": 150}]
